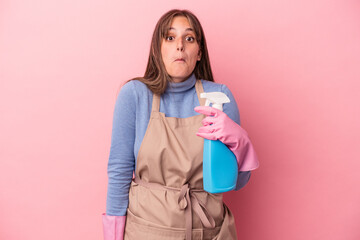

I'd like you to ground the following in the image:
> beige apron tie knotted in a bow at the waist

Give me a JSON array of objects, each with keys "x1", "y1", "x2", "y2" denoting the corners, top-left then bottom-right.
[{"x1": 134, "y1": 177, "x2": 215, "y2": 240}]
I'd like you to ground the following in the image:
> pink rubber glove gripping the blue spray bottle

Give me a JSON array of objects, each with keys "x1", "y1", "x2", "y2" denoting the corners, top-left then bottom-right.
[{"x1": 194, "y1": 106, "x2": 259, "y2": 171}]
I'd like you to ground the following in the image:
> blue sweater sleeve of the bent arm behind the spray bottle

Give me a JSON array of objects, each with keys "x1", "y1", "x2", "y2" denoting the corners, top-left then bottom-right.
[{"x1": 222, "y1": 85, "x2": 251, "y2": 191}]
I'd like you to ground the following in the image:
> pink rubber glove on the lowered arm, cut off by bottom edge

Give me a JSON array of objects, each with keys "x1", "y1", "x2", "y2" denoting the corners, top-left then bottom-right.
[{"x1": 102, "y1": 213, "x2": 126, "y2": 240}]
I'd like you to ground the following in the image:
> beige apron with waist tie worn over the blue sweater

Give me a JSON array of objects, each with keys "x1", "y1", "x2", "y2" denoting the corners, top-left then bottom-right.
[{"x1": 124, "y1": 80, "x2": 237, "y2": 240}]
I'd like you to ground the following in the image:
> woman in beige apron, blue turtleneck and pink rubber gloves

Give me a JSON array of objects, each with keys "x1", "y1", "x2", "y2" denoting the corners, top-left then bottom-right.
[{"x1": 103, "y1": 10, "x2": 258, "y2": 240}]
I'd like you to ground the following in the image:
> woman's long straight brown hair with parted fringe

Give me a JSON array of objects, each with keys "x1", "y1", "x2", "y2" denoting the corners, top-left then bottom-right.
[{"x1": 128, "y1": 9, "x2": 214, "y2": 94}]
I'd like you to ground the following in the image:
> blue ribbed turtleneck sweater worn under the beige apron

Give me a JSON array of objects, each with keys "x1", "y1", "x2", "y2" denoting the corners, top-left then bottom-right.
[{"x1": 106, "y1": 74, "x2": 251, "y2": 216}]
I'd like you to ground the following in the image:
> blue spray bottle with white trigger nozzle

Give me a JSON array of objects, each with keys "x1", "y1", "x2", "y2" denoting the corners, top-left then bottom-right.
[{"x1": 200, "y1": 92, "x2": 238, "y2": 193}]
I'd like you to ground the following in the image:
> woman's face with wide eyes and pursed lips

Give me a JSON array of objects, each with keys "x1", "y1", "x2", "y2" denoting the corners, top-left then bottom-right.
[{"x1": 161, "y1": 16, "x2": 201, "y2": 82}]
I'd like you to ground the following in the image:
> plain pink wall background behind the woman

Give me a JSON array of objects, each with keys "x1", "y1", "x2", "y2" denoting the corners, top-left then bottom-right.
[{"x1": 0, "y1": 0, "x2": 360, "y2": 240}]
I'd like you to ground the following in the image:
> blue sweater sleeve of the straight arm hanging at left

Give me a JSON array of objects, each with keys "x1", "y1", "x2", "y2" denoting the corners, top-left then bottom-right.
[{"x1": 106, "y1": 82, "x2": 136, "y2": 216}]
